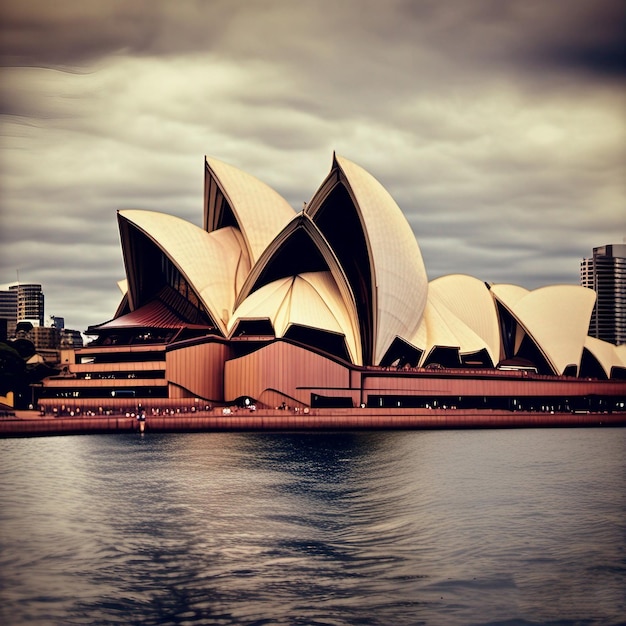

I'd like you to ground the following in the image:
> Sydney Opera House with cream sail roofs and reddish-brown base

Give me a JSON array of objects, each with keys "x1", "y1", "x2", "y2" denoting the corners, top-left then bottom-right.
[{"x1": 40, "y1": 155, "x2": 626, "y2": 410}]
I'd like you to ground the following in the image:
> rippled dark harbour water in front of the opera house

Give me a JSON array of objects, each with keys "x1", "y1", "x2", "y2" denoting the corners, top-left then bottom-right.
[{"x1": 0, "y1": 428, "x2": 626, "y2": 626}]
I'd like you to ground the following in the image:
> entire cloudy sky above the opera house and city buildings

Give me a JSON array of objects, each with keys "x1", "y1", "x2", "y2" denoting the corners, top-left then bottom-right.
[{"x1": 0, "y1": 0, "x2": 626, "y2": 330}]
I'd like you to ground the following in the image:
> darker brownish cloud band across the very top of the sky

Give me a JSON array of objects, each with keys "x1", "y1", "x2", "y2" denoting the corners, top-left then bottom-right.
[{"x1": 0, "y1": 0, "x2": 626, "y2": 79}]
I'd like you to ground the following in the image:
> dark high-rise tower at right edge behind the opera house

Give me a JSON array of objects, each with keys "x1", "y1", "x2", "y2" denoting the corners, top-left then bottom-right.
[{"x1": 580, "y1": 244, "x2": 626, "y2": 345}]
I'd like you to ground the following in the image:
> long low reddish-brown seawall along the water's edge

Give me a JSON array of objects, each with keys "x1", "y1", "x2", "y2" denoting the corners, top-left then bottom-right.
[{"x1": 0, "y1": 409, "x2": 626, "y2": 438}]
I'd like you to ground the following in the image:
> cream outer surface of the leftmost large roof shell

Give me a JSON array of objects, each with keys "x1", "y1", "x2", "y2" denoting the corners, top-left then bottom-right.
[{"x1": 119, "y1": 210, "x2": 250, "y2": 334}]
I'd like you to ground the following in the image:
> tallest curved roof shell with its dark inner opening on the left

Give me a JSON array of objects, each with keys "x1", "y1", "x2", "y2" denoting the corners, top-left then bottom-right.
[{"x1": 305, "y1": 156, "x2": 428, "y2": 364}]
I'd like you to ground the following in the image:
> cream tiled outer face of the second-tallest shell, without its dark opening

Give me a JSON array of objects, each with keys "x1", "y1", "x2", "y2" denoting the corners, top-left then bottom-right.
[{"x1": 205, "y1": 158, "x2": 295, "y2": 264}]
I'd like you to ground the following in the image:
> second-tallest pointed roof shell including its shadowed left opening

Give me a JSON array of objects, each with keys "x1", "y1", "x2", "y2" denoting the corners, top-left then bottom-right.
[{"x1": 204, "y1": 158, "x2": 295, "y2": 263}]
